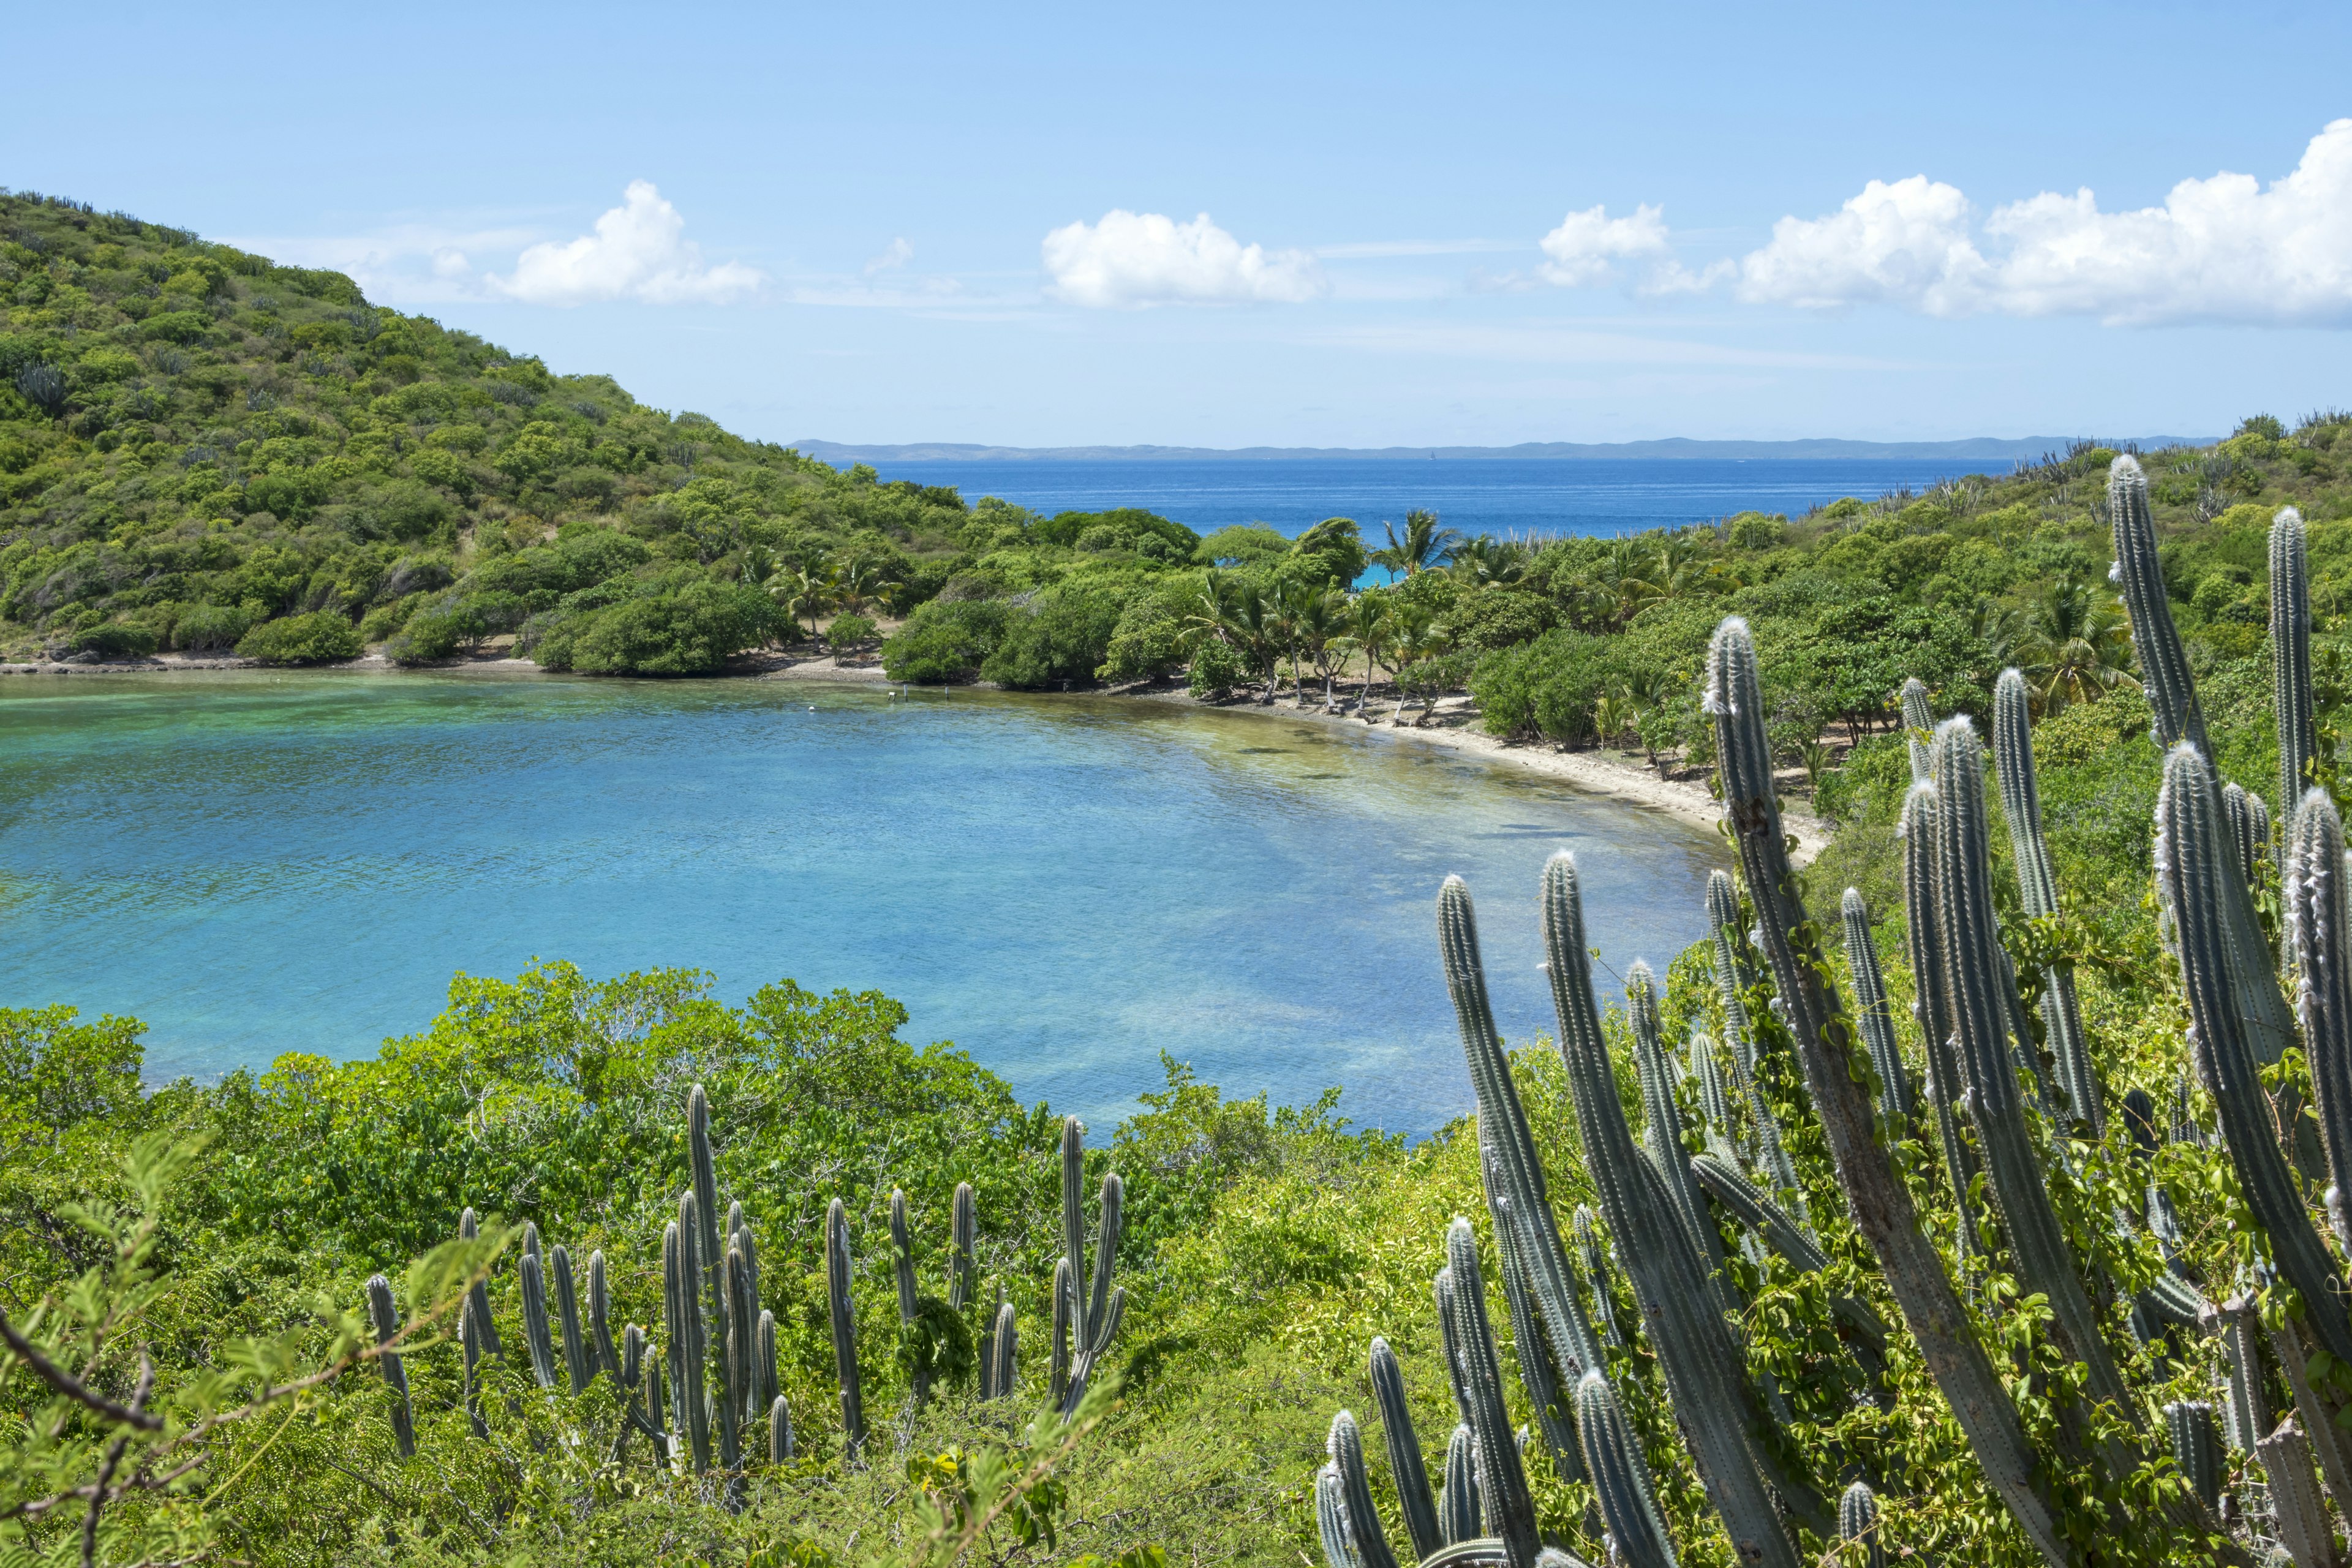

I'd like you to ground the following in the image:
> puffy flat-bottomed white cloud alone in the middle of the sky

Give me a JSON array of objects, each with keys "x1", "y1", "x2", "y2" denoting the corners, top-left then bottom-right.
[{"x1": 1044, "y1": 207, "x2": 1329, "y2": 308}]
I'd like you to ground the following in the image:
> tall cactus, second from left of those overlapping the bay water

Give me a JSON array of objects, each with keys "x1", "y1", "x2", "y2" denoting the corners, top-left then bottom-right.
[{"x1": 1524, "y1": 853, "x2": 1825, "y2": 1568}]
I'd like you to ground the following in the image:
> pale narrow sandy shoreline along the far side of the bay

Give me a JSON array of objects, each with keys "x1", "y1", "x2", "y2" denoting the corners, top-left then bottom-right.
[{"x1": 0, "y1": 654, "x2": 1832, "y2": 865}]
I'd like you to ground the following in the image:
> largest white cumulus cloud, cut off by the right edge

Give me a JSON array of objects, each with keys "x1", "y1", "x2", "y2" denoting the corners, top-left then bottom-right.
[{"x1": 1736, "y1": 120, "x2": 2352, "y2": 326}]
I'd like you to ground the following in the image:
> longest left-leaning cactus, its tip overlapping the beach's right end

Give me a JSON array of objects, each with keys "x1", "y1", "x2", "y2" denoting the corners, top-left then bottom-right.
[{"x1": 1705, "y1": 618, "x2": 2081, "y2": 1568}]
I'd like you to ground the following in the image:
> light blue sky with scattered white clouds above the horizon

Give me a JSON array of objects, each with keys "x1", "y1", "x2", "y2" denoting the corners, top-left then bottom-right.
[{"x1": 0, "y1": 0, "x2": 2352, "y2": 447}]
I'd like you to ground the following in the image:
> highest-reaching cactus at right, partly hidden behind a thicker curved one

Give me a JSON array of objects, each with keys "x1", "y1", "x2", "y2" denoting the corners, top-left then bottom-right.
[{"x1": 2108, "y1": 456, "x2": 2296, "y2": 1072}]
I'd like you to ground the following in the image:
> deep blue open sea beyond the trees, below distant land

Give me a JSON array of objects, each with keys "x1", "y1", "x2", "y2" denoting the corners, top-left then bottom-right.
[{"x1": 877, "y1": 458, "x2": 1994, "y2": 543}]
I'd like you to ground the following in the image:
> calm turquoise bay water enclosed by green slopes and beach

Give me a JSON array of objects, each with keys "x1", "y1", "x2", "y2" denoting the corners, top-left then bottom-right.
[{"x1": 0, "y1": 673, "x2": 1717, "y2": 1133}]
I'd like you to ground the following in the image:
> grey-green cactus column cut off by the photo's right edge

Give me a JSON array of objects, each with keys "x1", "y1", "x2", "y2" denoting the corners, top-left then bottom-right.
[{"x1": 2286, "y1": 790, "x2": 2352, "y2": 1251}]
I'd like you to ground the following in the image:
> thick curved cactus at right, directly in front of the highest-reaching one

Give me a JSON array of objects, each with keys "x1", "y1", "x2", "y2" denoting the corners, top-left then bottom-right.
[{"x1": 2154, "y1": 745, "x2": 2352, "y2": 1361}]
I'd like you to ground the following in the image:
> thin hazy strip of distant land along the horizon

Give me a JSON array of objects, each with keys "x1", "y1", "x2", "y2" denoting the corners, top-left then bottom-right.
[{"x1": 793, "y1": 435, "x2": 2220, "y2": 466}]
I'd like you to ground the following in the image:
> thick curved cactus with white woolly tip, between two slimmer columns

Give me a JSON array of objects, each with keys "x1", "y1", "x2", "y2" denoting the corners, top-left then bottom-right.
[{"x1": 1936, "y1": 717, "x2": 2136, "y2": 1438}]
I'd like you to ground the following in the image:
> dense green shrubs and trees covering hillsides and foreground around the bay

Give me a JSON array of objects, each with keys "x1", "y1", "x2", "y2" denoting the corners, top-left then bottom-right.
[{"x1": 23, "y1": 197, "x2": 2352, "y2": 1568}]
